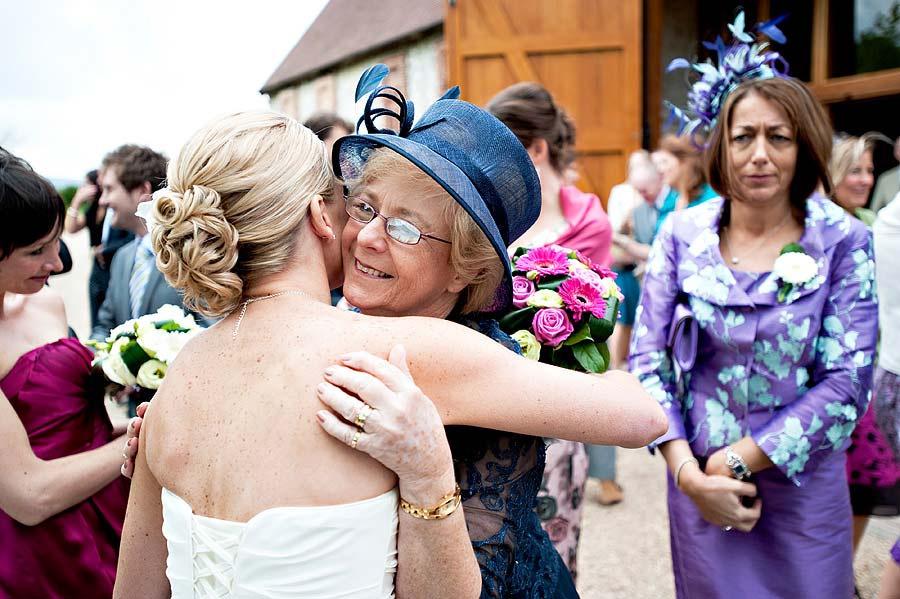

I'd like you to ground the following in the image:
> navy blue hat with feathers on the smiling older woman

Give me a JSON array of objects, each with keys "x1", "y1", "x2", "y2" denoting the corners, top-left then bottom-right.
[{"x1": 333, "y1": 65, "x2": 541, "y2": 310}]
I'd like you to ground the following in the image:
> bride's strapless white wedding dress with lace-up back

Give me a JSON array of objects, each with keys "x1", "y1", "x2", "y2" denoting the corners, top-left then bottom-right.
[{"x1": 162, "y1": 489, "x2": 398, "y2": 599}]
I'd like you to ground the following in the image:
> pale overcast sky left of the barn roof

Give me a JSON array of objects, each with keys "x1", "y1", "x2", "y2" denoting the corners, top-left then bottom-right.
[{"x1": 0, "y1": 0, "x2": 327, "y2": 179}]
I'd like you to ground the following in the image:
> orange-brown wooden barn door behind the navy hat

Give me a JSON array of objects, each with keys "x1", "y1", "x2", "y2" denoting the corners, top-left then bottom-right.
[{"x1": 444, "y1": 0, "x2": 643, "y2": 205}]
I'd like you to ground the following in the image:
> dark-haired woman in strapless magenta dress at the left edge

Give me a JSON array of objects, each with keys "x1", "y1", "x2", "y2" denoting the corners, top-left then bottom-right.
[{"x1": 0, "y1": 149, "x2": 128, "y2": 598}]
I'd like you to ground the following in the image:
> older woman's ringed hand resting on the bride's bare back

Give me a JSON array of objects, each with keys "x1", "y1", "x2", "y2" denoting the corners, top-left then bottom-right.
[{"x1": 316, "y1": 346, "x2": 453, "y2": 501}]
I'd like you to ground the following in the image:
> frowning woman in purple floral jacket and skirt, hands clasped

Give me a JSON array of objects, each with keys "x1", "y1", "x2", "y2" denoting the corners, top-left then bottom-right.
[{"x1": 631, "y1": 77, "x2": 878, "y2": 598}]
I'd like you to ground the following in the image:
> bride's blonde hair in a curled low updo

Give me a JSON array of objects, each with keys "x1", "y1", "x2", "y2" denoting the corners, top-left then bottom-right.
[{"x1": 151, "y1": 111, "x2": 332, "y2": 317}]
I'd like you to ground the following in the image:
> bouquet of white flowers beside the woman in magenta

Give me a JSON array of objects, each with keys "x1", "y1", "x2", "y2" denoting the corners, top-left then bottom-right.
[{"x1": 89, "y1": 304, "x2": 203, "y2": 390}]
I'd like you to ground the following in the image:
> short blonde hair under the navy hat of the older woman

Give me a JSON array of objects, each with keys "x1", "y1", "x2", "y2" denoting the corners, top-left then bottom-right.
[{"x1": 344, "y1": 148, "x2": 504, "y2": 314}]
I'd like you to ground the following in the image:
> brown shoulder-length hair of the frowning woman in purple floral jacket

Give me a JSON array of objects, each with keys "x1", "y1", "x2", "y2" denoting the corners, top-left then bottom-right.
[{"x1": 706, "y1": 77, "x2": 832, "y2": 222}]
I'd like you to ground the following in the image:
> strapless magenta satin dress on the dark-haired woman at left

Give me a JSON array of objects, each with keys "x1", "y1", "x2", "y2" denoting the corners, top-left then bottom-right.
[{"x1": 0, "y1": 339, "x2": 129, "y2": 599}]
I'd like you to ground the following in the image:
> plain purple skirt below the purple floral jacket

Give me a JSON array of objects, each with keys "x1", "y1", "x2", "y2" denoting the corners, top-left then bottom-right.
[{"x1": 668, "y1": 452, "x2": 853, "y2": 599}]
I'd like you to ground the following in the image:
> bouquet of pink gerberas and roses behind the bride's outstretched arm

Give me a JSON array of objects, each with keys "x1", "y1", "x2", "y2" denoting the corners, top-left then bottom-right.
[{"x1": 500, "y1": 245, "x2": 623, "y2": 372}]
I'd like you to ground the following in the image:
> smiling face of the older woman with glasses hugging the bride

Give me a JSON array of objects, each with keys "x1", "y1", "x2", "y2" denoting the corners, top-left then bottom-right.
[{"x1": 342, "y1": 165, "x2": 465, "y2": 318}]
